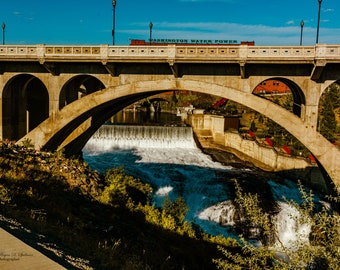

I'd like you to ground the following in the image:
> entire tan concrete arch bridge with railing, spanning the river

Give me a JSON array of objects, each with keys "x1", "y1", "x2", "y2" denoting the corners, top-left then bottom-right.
[{"x1": 0, "y1": 45, "x2": 340, "y2": 187}]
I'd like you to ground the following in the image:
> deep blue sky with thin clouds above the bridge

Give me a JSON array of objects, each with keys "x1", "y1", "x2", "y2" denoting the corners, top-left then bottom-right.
[{"x1": 0, "y1": 0, "x2": 340, "y2": 45}]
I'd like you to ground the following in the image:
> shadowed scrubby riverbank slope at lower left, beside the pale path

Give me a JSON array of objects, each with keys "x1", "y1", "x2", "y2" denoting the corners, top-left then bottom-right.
[{"x1": 0, "y1": 142, "x2": 239, "y2": 270}]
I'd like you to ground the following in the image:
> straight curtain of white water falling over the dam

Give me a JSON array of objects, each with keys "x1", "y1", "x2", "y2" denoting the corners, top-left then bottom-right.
[{"x1": 84, "y1": 125, "x2": 196, "y2": 151}]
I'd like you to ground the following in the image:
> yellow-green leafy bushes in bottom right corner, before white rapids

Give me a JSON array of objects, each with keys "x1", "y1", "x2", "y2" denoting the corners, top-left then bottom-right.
[{"x1": 213, "y1": 179, "x2": 340, "y2": 270}]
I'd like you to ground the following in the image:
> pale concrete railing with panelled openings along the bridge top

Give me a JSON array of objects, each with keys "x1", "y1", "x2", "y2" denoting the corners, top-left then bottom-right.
[{"x1": 0, "y1": 44, "x2": 340, "y2": 62}]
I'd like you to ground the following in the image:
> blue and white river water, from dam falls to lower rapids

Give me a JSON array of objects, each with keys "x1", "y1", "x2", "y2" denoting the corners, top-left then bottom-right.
[{"x1": 83, "y1": 125, "x2": 310, "y2": 247}]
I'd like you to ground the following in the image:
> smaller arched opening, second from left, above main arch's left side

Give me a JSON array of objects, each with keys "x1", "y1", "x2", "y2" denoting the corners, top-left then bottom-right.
[{"x1": 59, "y1": 75, "x2": 105, "y2": 109}]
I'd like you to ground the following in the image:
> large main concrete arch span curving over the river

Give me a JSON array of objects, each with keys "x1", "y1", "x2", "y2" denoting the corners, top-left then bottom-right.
[{"x1": 19, "y1": 77, "x2": 340, "y2": 188}]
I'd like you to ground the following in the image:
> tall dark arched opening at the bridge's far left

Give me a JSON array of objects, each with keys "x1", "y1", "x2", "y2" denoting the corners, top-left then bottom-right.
[{"x1": 2, "y1": 74, "x2": 49, "y2": 140}]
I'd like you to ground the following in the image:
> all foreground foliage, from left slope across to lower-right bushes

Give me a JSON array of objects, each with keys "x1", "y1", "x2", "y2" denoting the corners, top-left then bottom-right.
[{"x1": 0, "y1": 142, "x2": 340, "y2": 269}]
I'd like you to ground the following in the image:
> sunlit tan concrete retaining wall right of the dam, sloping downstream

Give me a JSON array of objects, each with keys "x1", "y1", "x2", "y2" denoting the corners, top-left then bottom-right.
[{"x1": 188, "y1": 114, "x2": 329, "y2": 192}]
